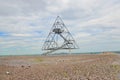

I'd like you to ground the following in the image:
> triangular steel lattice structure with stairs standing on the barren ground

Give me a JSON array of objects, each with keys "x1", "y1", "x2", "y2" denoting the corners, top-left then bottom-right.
[{"x1": 42, "y1": 16, "x2": 78, "y2": 54}]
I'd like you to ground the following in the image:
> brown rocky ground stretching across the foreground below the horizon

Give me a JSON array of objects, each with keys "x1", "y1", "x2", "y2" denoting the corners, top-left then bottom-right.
[{"x1": 0, "y1": 53, "x2": 120, "y2": 80}]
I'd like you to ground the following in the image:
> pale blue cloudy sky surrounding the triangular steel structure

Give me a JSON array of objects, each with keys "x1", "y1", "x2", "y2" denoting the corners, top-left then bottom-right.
[{"x1": 0, "y1": 0, "x2": 120, "y2": 55}]
